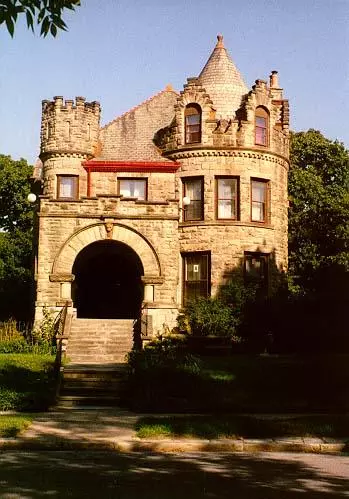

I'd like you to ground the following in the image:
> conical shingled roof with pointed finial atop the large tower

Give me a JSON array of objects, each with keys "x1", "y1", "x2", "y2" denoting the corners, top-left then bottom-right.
[{"x1": 199, "y1": 35, "x2": 248, "y2": 118}]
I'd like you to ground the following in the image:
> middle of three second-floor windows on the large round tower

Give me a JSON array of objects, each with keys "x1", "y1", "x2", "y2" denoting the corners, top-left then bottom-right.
[{"x1": 216, "y1": 177, "x2": 238, "y2": 220}]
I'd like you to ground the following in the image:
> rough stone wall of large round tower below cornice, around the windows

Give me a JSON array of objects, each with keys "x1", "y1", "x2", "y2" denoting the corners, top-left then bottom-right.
[{"x1": 177, "y1": 151, "x2": 288, "y2": 294}]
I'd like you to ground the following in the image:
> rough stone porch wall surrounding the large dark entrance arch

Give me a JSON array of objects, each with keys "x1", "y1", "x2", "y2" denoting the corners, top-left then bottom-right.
[{"x1": 36, "y1": 197, "x2": 179, "y2": 332}]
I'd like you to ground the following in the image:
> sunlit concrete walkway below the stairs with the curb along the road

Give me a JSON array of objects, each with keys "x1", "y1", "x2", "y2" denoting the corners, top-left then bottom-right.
[{"x1": 0, "y1": 408, "x2": 349, "y2": 454}]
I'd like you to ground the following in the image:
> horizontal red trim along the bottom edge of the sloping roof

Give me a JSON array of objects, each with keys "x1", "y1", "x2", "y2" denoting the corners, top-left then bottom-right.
[{"x1": 82, "y1": 160, "x2": 180, "y2": 173}]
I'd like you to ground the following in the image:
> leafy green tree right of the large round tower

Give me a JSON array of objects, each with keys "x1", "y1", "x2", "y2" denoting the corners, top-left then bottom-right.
[{"x1": 289, "y1": 130, "x2": 349, "y2": 290}]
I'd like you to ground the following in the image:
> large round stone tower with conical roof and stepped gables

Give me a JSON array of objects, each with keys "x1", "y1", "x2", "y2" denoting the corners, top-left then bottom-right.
[{"x1": 160, "y1": 35, "x2": 289, "y2": 304}]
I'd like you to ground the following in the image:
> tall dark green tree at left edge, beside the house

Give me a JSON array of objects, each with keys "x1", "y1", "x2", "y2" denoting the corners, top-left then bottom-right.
[{"x1": 0, "y1": 155, "x2": 33, "y2": 320}]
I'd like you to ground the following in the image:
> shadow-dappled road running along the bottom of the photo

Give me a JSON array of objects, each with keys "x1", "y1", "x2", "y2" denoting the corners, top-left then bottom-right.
[{"x1": 0, "y1": 451, "x2": 349, "y2": 499}]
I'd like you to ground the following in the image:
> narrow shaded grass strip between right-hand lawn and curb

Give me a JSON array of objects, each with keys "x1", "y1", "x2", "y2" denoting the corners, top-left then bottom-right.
[{"x1": 136, "y1": 415, "x2": 349, "y2": 439}]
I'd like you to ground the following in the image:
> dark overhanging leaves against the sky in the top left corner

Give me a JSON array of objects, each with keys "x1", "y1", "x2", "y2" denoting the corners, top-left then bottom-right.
[{"x1": 0, "y1": 0, "x2": 80, "y2": 37}]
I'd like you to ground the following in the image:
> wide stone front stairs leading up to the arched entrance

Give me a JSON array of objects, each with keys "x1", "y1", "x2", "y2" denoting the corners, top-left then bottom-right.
[{"x1": 57, "y1": 318, "x2": 133, "y2": 408}]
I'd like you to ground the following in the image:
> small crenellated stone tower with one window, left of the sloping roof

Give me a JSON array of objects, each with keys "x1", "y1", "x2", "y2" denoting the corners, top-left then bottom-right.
[{"x1": 40, "y1": 97, "x2": 101, "y2": 199}]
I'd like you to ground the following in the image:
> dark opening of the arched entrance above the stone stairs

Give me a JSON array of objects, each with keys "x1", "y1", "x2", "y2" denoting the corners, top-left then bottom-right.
[{"x1": 72, "y1": 240, "x2": 144, "y2": 319}]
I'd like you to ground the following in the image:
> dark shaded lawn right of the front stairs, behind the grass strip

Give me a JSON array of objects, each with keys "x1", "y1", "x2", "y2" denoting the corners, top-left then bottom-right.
[{"x1": 131, "y1": 355, "x2": 349, "y2": 414}]
